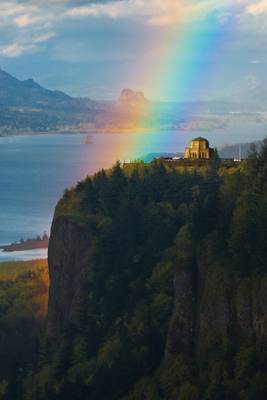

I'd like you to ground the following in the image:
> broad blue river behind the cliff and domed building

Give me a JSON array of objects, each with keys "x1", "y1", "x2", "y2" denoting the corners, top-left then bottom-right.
[{"x1": 0, "y1": 124, "x2": 267, "y2": 259}]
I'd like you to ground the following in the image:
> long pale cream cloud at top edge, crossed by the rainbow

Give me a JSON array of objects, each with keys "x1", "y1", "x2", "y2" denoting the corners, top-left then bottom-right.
[{"x1": 63, "y1": 0, "x2": 254, "y2": 26}]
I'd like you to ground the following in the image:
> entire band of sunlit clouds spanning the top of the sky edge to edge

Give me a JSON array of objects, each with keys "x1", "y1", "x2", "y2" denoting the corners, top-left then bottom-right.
[{"x1": 0, "y1": 0, "x2": 267, "y2": 57}]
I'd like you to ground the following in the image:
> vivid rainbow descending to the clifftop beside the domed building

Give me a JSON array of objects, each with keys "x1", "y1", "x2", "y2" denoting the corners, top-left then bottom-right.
[{"x1": 98, "y1": 11, "x2": 233, "y2": 166}]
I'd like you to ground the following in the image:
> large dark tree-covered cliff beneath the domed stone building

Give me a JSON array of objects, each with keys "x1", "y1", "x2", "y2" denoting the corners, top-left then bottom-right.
[{"x1": 35, "y1": 151, "x2": 267, "y2": 400}]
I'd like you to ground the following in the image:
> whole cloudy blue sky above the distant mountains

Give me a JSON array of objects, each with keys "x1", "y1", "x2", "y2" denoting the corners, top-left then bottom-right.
[{"x1": 0, "y1": 0, "x2": 267, "y2": 103}]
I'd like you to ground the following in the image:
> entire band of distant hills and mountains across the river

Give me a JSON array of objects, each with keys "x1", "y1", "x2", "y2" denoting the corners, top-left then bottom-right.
[{"x1": 0, "y1": 69, "x2": 267, "y2": 136}]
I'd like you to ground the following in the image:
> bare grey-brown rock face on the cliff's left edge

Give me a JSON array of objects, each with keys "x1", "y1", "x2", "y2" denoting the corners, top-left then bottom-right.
[{"x1": 47, "y1": 217, "x2": 90, "y2": 339}]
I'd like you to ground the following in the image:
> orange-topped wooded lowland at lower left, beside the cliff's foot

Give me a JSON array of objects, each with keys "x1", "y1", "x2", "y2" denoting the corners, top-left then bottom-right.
[{"x1": 0, "y1": 260, "x2": 49, "y2": 399}]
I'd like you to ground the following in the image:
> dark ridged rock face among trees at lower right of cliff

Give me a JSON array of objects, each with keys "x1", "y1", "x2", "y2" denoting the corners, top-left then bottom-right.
[{"x1": 166, "y1": 264, "x2": 267, "y2": 360}]
